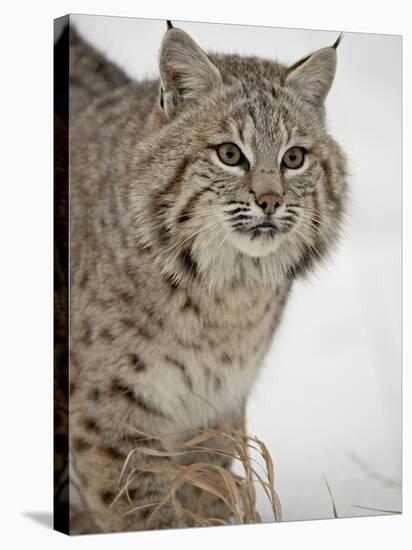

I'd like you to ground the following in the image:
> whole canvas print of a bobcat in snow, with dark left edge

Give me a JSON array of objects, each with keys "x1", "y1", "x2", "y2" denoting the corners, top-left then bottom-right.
[{"x1": 54, "y1": 15, "x2": 401, "y2": 534}]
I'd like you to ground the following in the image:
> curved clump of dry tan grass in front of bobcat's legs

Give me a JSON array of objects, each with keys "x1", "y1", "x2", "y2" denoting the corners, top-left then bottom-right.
[{"x1": 112, "y1": 429, "x2": 281, "y2": 528}]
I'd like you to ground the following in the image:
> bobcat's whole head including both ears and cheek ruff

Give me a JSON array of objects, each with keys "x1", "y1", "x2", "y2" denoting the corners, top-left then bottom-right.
[{"x1": 130, "y1": 29, "x2": 346, "y2": 288}]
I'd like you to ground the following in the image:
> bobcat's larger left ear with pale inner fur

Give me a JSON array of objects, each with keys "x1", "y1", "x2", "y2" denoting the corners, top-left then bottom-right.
[{"x1": 159, "y1": 25, "x2": 222, "y2": 118}]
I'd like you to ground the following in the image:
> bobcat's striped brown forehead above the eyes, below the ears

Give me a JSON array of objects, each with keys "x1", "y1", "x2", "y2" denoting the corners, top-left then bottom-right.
[{"x1": 182, "y1": 76, "x2": 326, "y2": 169}]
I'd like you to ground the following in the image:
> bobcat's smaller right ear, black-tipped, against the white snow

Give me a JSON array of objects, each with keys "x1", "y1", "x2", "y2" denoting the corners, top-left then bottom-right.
[{"x1": 285, "y1": 46, "x2": 339, "y2": 107}]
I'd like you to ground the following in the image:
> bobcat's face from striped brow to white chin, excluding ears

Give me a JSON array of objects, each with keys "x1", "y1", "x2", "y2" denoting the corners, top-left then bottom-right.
[{"x1": 163, "y1": 89, "x2": 345, "y2": 264}]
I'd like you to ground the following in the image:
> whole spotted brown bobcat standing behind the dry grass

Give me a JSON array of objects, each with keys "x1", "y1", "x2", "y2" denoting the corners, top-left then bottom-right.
[{"x1": 61, "y1": 23, "x2": 347, "y2": 532}]
